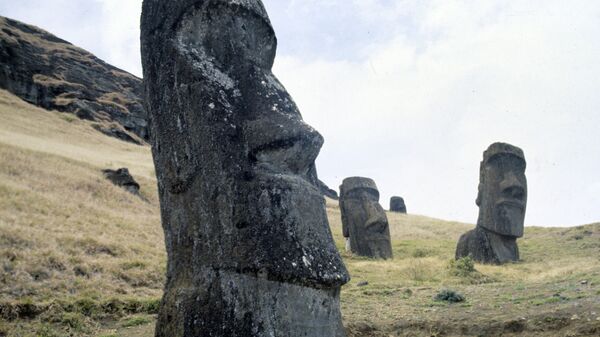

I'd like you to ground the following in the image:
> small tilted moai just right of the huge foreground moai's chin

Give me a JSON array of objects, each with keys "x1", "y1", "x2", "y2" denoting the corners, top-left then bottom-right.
[{"x1": 340, "y1": 177, "x2": 392, "y2": 259}]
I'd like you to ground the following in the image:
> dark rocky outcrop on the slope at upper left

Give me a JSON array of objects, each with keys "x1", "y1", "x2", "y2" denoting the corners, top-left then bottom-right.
[{"x1": 0, "y1": 16, "x2": 148, "y2": 144}]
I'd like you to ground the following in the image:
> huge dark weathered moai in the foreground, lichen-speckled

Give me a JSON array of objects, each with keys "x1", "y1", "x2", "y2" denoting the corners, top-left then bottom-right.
[{"x1": 141, "y1": 0, "x2": 349, "y2": 337}]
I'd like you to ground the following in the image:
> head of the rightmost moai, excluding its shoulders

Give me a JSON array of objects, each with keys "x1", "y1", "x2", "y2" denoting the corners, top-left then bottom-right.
[{"x1": 476, "y1": 143, "x2": 527, "y2": 238}]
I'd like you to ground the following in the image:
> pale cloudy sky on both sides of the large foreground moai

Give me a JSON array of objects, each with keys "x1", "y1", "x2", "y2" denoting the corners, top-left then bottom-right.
[{"x1": 0, "y1": 0, "x2": 600, "y2": 226}]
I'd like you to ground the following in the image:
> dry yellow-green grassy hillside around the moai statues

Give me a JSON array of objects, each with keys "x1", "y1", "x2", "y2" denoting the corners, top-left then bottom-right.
[{"x1": 0, "y1": 91, "x2": 600, "y2": 337}]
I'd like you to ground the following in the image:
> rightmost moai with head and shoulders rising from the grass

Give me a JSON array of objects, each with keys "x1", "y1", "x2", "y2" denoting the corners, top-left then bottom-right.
[{"x1": 456, "y1": 143, "x2": 527, "y2": 264}]
